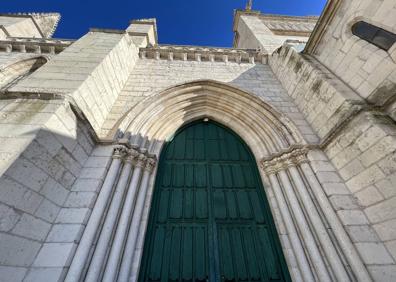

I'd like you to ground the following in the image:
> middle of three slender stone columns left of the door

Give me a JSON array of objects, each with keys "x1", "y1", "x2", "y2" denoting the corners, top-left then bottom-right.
[{"x1": 103, "y1": 151, "x2": 146, "y2": 281}]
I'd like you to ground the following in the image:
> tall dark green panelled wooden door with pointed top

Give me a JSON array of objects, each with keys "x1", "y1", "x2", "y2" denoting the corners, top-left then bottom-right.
[{"x1": 139, "y1": 122, "x2": 290, "y2": 281}]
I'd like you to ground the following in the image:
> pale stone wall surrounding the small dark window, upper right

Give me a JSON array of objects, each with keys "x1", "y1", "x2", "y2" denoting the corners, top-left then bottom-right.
[{"x1": 313, "y1": 0, "x2": 396, "y2": 119}]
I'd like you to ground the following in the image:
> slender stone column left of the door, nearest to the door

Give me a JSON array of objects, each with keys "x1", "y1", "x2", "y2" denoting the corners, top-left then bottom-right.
[{"x1": 118, "y1": 159, "x2": 156, "y2": 282}]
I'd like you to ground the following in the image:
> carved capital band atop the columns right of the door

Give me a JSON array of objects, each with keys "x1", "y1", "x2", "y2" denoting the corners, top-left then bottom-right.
[{"x1": 260, "y1": 146, "x2": 316, "y2": 175}]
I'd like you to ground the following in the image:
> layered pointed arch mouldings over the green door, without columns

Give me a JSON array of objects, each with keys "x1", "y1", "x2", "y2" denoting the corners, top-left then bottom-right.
[{"x1": 113, "y1": 80, "x2": 306, "y2": 160}]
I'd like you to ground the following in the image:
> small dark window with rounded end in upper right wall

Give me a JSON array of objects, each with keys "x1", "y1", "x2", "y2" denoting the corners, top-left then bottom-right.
[{"x1": 352, "y1": 21, "x2": 396, "y2": 51}]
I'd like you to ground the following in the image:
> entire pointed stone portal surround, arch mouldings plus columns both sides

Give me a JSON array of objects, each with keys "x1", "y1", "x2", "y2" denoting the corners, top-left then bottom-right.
[{"x1": 66, "y1": 80, "x2": 371, "y2": 281}]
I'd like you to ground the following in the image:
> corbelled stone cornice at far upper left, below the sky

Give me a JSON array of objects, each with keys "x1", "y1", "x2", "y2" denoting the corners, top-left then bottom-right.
[{"x1": 0, "y1": 37, "x2": 74, "y2": 54}]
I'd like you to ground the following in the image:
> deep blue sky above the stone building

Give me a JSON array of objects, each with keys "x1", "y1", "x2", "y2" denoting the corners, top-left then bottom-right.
[{"x1": 1, "y1": 0, "x2": 326, "y2": 47}]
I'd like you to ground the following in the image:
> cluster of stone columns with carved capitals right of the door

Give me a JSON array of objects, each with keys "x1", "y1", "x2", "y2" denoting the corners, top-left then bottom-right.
[{"x1": 262, "y1": 147, "x2": 371, "y2": 281}]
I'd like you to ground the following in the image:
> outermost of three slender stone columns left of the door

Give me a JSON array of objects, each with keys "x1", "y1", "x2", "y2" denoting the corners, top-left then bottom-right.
[{"x1": 85, "y1": 151, "x2": 134, "y2": 282}]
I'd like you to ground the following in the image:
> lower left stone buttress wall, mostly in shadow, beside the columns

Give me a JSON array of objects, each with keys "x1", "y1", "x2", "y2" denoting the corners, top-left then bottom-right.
[{"x1": 0, "y1": 100, "x2": 103, "y2": 281}]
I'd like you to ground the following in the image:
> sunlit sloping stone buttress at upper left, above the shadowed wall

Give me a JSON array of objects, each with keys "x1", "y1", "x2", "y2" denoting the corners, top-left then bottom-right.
[{"x1": 9, "y1": 31, "x2": 142, "y2": 132}]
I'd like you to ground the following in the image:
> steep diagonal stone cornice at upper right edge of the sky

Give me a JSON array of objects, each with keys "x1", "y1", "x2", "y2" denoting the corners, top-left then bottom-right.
[{"x1": 303, "y1": 0, "x2": 342, "y2": 54}]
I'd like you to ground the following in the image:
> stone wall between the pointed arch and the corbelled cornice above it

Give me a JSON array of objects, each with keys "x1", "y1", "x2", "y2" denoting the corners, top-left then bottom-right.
[{"x1": 102, "y1": 56, "x2": 318, "y2": 143}]
